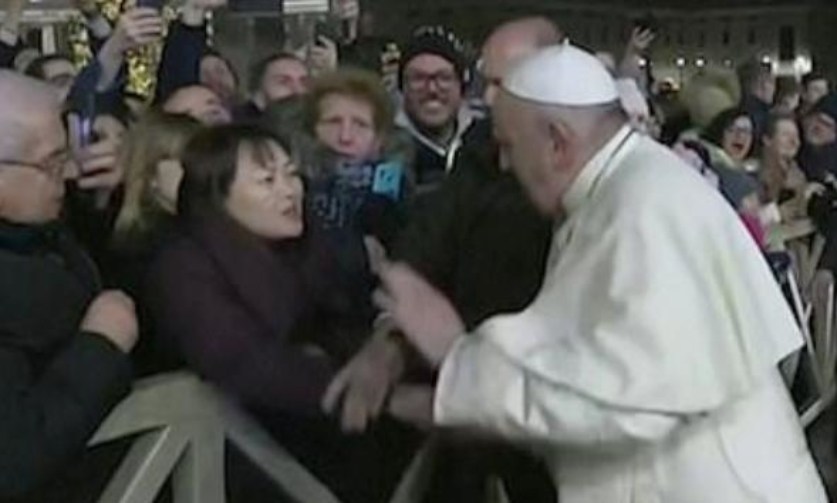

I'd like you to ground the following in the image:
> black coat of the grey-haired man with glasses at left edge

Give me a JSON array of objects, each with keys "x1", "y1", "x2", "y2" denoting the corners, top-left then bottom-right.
[{"x1": 0, "y1": 223, "x2": 131, "y2": 500}]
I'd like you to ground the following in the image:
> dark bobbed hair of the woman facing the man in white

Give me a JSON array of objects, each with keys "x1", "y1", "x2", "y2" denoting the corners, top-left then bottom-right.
[{"x1": 177, "y1": 125, "x2": 291, "y2": 218}]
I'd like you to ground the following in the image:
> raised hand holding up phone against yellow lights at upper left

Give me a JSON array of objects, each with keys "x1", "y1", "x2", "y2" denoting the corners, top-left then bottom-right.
[{"x1": 97, "y1": 8, "x2": 165, "y2": 91}]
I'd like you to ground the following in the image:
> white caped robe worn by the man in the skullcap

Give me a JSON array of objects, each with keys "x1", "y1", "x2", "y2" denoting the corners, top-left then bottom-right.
[{"x1": 434, "y1": 128, "x2": 826, "y2": 503}]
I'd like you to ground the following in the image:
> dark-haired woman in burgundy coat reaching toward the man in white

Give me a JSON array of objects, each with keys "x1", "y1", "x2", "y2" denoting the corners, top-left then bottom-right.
[{"x1": 147, "y1": 126, "x2": 419, "y2": 503}]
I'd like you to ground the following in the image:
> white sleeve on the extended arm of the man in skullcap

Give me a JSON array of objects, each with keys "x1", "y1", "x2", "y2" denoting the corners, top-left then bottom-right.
[{"x1": 434, "y1": 335, "x2": 687, "y2": 449}]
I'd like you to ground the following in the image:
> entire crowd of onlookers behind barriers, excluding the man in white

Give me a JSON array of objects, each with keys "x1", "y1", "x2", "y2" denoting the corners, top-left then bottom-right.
[{"x1": 0, "y1": 0, "x2": 837, "y2": 503}]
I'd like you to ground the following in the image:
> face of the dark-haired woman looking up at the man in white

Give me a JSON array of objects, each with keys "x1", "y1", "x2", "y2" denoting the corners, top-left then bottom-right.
[{"x1": 225, "y1": 141, "x2": 304, "y2": 240}]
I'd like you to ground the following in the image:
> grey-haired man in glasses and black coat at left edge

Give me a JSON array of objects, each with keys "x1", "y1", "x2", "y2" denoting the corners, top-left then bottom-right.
[{"x1": 0, "y1": 71, "x2": 137, "y2": 501}]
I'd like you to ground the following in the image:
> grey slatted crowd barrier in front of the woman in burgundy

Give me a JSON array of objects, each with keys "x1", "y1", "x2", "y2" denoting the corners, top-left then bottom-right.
[{"x1": 90, "y1": 372, "x2": 433, "y2": 503}]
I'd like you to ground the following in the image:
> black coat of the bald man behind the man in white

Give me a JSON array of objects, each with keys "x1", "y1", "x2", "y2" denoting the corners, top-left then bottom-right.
[{"x1": 395, "y1": 121, "x2": 552, "y2": 328}]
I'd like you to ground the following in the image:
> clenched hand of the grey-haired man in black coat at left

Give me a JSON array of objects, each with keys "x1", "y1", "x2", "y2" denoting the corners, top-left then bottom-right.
[{"x1": 81, "y1": 290, "x2": 139, "y2": 353}]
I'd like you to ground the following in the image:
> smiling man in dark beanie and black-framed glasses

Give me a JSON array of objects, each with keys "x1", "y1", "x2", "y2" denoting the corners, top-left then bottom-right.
[{"x1": 396, "y1": 26, "x2": 480, "y2": 187}]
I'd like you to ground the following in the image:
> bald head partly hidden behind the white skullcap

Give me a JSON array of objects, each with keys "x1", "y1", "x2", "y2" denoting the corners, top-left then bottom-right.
[{"x1": 481, "y1": 17, "x2": 564, "y2": 106}]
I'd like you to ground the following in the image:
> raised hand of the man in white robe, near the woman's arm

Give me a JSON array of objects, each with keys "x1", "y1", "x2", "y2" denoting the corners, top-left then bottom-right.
[{"x1": 375, "y1": 263, "x2": 465, "y2": 367}]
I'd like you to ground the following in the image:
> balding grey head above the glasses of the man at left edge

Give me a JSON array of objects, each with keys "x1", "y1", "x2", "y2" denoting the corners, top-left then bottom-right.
[{"x1": 0, "y1": 70, "x2": 64, "y2": 159}]
